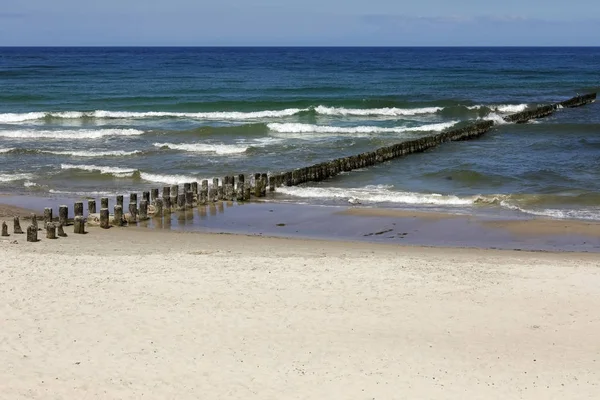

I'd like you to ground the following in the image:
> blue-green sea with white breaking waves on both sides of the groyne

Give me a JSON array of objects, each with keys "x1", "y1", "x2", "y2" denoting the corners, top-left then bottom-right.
[{"x1": 0, "y1": 47, "x2": 600, "y2": 220}]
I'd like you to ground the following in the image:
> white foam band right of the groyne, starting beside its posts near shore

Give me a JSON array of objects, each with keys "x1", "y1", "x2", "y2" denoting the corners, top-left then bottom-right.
[{"x1": 277, "y1": 185, "x2": 473, "y2": 206}]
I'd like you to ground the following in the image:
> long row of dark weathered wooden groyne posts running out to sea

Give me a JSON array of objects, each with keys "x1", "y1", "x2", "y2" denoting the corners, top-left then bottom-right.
[{"x1": 1, "y1": 93, "x2": 596, "y2": 242}]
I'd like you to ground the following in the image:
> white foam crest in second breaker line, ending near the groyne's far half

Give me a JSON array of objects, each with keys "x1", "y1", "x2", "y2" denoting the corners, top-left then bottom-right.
[{"x1": 267, "y1": 121, "x2": 458, "y2": 134}]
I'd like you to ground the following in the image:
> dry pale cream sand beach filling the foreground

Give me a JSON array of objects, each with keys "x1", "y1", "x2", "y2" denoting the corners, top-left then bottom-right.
[{"x1": 0, "y1": 228, "x2": 600, "y2": 399}]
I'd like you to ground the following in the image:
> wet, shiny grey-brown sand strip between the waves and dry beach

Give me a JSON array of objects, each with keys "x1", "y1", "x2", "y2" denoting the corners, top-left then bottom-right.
[{"x1": 0, "y1": 197, "x2": 600, "y2": 253}]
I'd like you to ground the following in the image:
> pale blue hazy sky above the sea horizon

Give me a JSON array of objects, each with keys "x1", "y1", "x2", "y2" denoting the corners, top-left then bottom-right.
[{"x1": 0, "y1": 0, "x2": 600, "y2": 46}]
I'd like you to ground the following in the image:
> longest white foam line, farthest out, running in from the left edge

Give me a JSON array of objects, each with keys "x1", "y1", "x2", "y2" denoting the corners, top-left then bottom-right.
[{"x1": 0, "y1": 108, "x2": 308, "y2": 123}]
